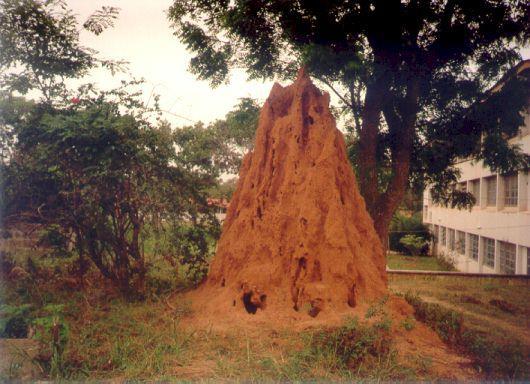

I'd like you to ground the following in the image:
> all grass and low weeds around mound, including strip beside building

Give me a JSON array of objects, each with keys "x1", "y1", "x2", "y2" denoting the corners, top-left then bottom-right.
[{"x1": 0, "y1": 236, "x2": 530, "y2": 381}]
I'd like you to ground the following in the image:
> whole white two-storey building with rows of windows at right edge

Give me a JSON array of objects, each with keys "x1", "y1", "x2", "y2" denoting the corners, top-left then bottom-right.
[{"x1": 423, "y1": 60, "x2": 530, "y2": 275}]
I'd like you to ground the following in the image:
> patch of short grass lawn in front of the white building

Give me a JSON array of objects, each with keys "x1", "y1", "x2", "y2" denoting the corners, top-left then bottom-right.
[{"x1": 389, "y1": 275, "x2": 530, "y2": 379}]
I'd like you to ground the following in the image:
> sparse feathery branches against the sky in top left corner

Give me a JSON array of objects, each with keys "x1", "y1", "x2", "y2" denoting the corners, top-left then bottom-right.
[{"x1": 0, "y1": 0, "x2": 120, "y2": 103}]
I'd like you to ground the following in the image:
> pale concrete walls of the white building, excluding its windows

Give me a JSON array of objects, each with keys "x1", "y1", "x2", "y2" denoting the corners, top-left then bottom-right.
[{"x1": 423, "y1": 116, "x2": 530, "y2": 274}]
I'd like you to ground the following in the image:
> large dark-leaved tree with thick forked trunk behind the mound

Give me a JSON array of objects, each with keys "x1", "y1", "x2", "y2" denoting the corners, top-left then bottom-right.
[{"x1": 169, "y1": 0, "x2": 530, "y2": 243}]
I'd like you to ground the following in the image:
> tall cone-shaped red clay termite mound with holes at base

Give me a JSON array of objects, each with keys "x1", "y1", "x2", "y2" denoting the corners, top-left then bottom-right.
[{"x1": 199, "y1": 71, "x2": 387, "y2": 317}]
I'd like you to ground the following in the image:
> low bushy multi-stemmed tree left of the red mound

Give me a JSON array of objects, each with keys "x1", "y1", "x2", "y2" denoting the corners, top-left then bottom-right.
[{"x1": 0, "y1": 88, "x2": 217, "y2": 297}]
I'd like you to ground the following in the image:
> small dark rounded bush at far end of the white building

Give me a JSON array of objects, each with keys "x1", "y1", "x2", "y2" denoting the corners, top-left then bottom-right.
[{"x1": 388, "y1": 213, "x2": 431, "y2": 255}]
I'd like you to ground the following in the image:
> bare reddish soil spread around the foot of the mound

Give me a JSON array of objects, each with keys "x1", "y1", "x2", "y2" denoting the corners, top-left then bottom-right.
[{"x1": 176, "y1": 296, "x2": 474, "y2": 381}]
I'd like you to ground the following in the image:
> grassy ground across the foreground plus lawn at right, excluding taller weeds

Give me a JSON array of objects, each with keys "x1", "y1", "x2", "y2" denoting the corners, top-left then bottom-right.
[{"x1": 2, "y1": 276, "x2": 530, "y2": 381}]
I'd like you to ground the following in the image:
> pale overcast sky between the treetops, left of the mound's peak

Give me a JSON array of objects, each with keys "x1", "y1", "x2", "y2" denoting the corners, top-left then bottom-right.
[{"x1": 68, "y1": 0, "x2": 530, "y2": 125}]
